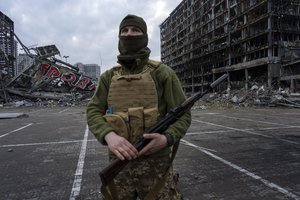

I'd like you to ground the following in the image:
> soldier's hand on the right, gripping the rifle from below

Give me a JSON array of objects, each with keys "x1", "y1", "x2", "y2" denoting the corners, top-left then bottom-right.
[{"x1": 139, "y1": 133, "x2": 167, "y2": 156}]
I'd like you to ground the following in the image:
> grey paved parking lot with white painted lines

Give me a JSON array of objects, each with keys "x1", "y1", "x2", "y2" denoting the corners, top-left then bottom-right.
[{"x1": 0, "y1": 107, "x2": 300, "y2": 200}]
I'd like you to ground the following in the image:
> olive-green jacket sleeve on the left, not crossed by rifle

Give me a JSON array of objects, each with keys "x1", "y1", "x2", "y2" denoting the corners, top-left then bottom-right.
[{"x1": 87, "y1": 71, "x2": 113, "y2": 144}]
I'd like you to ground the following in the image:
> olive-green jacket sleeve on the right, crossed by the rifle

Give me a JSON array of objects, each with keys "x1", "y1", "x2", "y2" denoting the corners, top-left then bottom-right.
[{"x1": 158, "y1": 65, "x2": 191, "y2": 142}]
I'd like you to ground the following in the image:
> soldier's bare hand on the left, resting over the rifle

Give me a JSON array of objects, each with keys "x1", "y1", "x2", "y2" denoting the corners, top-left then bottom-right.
[{"x1": 104, "y1": 132, "x2": 138, "y2": 160}]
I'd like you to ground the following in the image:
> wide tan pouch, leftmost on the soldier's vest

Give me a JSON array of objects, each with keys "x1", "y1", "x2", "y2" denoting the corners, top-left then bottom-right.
[{"x1": 103, "y1": 112, "x2": 129, "y2": 140}]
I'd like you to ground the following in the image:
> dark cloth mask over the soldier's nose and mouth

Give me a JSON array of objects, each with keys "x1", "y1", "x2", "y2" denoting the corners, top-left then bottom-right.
[{"x1": 119, "y1": 34, "x2": 148, "y2": 55}]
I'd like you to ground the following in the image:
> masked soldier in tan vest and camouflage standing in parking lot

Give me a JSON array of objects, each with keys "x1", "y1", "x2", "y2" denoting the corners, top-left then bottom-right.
[{"x1": 87, "y1": 15, "x2": 191, "y2": 200}]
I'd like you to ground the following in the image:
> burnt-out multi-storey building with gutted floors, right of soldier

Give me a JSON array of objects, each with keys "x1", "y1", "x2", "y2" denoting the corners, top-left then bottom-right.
[{"x1": 160, "y1": 0, "x2": 300, "y2": 94}]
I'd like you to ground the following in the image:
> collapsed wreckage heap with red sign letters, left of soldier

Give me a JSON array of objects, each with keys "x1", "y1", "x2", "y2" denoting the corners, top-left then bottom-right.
[{"x1": 0, "y1": 32, "x2": 97, "y2": 107}]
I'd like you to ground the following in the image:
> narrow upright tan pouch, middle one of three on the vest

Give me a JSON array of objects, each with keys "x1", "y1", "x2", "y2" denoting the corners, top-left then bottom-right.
[{"x1": 128, "y1": 107, "x2": 144, "y2": 143}]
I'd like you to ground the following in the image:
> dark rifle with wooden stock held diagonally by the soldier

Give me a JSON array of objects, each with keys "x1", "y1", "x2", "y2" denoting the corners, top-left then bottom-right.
[{"x1": 99, "y1": 74, "x2": 228, "y2": 186}]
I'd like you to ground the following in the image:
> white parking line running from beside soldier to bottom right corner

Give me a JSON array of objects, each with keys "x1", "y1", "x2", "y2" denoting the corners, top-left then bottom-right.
[{"x1": 184, "y1": 140, "x2": 300, "y2": 200}]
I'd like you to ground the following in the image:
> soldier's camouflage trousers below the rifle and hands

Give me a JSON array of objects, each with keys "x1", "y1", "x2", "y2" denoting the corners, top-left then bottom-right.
[{"x1": 103, "y1": 156, "x2": 183, "y2": 200}]
